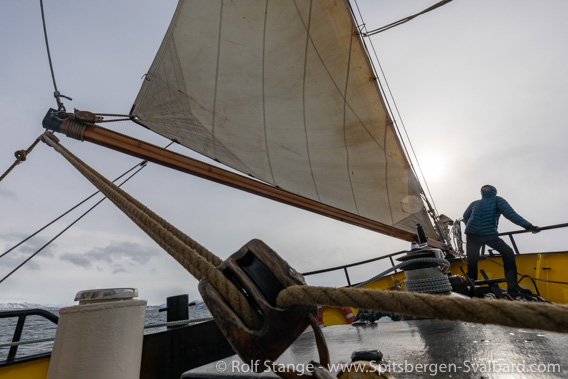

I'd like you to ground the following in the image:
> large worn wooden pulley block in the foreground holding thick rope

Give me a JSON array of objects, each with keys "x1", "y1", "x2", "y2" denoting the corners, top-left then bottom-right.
[{"x1": 199, "y1": 239, "x2": 316, "y2": 370}]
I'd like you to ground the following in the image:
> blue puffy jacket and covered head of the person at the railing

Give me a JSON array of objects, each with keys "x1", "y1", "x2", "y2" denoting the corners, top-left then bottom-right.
[{"x1": 463, "y1": 186, "x2": 531, "y2": 235}]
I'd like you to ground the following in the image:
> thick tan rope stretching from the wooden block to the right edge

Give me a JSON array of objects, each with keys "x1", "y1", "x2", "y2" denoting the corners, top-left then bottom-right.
[{"x1": 276, "y1": 286, "x2": 568, "y2": 333}]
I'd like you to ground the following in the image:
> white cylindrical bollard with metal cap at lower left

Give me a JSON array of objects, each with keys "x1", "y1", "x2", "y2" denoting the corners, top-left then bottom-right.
[{"x1": 47, "y1": 288, "x2": 146, "y2": 379}]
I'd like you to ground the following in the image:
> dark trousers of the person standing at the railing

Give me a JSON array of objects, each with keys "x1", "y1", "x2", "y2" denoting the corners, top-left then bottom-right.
[{"x1": 466, "y1": 234, "x2": 517, "y2": 290}]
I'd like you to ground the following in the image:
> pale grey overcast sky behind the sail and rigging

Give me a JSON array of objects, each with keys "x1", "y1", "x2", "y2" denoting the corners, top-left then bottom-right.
[{"x1": 0, "y1": 0, "x2": 568, "y2": 304}]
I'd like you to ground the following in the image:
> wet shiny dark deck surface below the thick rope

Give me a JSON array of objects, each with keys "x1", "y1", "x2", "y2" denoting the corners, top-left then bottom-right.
[{"x1": 182, "y1": 320, "x2": 568, "y2": 379}]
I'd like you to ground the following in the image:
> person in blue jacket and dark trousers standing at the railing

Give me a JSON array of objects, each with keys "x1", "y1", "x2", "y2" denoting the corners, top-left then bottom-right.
[{"x1": 463, "y1": 185, "x2": 539, "y2": 292}]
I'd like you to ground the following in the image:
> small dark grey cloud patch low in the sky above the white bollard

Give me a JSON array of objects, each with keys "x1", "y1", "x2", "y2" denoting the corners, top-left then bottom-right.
[{"x1": 60, "y1": 241, "x2": 159, "y2": 274}]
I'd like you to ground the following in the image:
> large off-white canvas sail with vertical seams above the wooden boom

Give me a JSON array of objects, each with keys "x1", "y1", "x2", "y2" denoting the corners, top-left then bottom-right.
[{"x1": 133, "y1": 0, "x2": 435, "y2": 237}]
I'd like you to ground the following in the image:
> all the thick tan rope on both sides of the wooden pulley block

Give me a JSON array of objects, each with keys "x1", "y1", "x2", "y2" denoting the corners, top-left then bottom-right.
[{"x1": 42, "y1": 132, "x2": 568, "y2": 333}]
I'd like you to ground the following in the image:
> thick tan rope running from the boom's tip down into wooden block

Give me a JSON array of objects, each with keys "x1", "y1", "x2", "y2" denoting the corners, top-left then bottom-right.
[{"x1": 43, "y1": 133, "x2": 260, "y2": 329}]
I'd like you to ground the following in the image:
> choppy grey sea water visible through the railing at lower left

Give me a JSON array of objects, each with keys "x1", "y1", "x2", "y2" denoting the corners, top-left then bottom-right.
[{"x1": 0, "y1": 307, "x2": 211, "y2": 362}]
